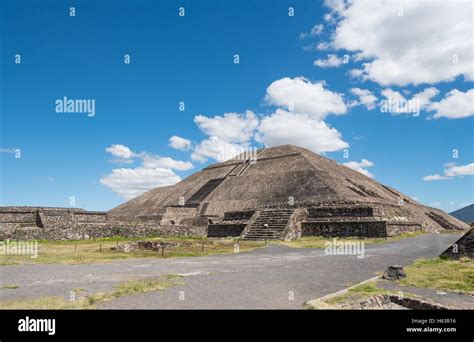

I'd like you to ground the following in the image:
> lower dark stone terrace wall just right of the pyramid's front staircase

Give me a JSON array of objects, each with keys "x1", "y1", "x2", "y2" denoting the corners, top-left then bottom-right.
[{"x1": 301, "y1": 221, "x2": 388, "y2": 237}]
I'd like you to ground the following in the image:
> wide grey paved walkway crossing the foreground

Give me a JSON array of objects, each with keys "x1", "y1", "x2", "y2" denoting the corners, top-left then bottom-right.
[{"x1": 0, "y1": 235, "x2": 459, "y2": 309}]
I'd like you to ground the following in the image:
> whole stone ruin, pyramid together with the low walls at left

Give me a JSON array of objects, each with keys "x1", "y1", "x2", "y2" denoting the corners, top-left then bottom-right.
[{"x1": 0, "y1": 145, "x2": 469, "y2": 240}]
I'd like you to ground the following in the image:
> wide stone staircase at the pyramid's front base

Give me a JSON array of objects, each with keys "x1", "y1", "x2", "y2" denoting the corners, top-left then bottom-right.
[{"x1": 241, "y1": 209, "x2": 293, "y2": 240}]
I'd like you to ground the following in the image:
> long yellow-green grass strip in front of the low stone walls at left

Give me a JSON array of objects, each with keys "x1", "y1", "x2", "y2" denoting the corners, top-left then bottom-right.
[{"x1": 0, "y1": 237, "x2": 265, "y2": 266}]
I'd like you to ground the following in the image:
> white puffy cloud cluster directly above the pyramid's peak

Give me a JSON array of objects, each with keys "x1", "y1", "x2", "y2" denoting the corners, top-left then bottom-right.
[{"x1": 191, "y1": 77, "x2": 349, "y2": 162}]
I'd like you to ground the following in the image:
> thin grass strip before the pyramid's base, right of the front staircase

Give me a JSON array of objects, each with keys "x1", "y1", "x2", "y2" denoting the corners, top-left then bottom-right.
[{"x1": 272, "y1": 232, "x2": 425, "y2": 248}]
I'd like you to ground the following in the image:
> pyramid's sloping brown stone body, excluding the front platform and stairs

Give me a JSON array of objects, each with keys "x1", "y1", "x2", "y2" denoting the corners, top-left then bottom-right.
[{"x1": 108, "y1": 145, "x2": 468, "y2": 232}]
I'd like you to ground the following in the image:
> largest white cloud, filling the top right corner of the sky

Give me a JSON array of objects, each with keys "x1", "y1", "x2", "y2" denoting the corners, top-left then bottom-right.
[{"x1": 326, "y1": 0, "x2": 474, "y2": 86}]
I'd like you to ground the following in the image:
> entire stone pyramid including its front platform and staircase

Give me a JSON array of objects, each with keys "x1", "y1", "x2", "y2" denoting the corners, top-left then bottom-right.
[{"x1": 108, "y1": 145, "x2": 468, "y2": 238}]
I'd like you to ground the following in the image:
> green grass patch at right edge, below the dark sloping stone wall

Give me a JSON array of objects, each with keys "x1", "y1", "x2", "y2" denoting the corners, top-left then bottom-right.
[{"x1": 399, "y1": 258, "x2": 474, "y2": 294}]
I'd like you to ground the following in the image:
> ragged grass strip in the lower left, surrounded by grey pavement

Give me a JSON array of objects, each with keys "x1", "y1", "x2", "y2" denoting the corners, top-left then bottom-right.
[{"x1": 0, "y1": 275, "x2": 183, "y2": 310}]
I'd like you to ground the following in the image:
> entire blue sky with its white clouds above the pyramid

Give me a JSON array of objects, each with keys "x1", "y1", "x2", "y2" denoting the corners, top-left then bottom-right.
[{"x1": 0, "y1": 0, "x2": 474, "y2": 211}]
